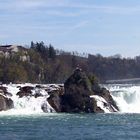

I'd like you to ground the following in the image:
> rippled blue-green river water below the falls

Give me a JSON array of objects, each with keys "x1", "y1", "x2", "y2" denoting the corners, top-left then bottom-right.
[{"x1": 0, "y1": 114, "x2": 140, "y2": 140}]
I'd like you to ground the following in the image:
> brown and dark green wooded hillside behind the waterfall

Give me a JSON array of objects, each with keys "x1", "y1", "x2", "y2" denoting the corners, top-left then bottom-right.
[{"x1": 0, "y1": 42, "x2": 140, "y2": 83}]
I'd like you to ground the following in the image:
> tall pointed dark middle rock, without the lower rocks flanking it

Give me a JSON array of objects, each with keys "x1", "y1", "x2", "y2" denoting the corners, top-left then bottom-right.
[{"x1": 61, "y1": 68, "x2": 103, "y2": 113}]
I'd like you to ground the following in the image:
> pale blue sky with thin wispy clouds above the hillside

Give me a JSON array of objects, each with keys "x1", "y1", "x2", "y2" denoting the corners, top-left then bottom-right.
[{"x1": 0, "y1": 0, "x2": 140, "y2": 57}]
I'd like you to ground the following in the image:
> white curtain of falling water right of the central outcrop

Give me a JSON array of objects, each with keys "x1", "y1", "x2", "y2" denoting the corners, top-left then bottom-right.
[{"x1": 107, "y1": 85, "x2": 140, "y2": 113}]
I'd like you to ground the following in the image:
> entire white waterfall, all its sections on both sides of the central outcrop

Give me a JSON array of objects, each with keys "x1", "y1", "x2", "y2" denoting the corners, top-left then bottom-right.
[{"x1": 0, "y1": 84, "x2": 140, "y2": 115}]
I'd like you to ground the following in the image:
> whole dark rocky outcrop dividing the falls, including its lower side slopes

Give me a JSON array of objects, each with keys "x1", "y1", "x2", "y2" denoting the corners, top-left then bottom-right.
[{"x1": 48, "y1": 69, "x2": 118, "y2": 113}]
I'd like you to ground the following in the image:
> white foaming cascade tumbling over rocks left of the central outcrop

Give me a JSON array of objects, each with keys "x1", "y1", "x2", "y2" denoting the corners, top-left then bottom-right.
[{"x1": 0, "y1": 84, "x2": 55, "y2": 115}]
